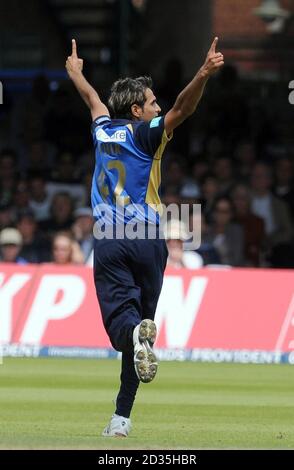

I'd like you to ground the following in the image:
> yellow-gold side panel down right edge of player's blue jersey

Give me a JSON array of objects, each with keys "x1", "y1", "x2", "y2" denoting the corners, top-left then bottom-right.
[{"x1": 145, "y1": 130, "x2": 173, "y2": 215}]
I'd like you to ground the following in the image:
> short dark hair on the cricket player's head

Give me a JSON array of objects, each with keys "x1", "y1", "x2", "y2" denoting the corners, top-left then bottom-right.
[{"x1": 108, "y1": 77, "x2": 152, "y2": 119}]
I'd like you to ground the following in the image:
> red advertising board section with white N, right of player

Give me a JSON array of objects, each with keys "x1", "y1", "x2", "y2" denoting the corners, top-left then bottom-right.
[{"x1": 157, "y1": 269, "x2": 294, "y2": 351}]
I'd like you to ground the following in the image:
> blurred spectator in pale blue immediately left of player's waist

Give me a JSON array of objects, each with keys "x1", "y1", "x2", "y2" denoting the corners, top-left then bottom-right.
[{"x1": 72, "y1": 207, "x2": 94, "y2": 263}]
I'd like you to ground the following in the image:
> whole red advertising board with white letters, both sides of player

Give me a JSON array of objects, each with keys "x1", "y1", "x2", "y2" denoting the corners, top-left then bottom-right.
[{"x1": 0, "y1": 264, "x2": 294, "y2": 352}]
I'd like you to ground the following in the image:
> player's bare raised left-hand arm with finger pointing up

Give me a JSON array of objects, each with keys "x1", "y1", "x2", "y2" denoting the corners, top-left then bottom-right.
[{"x1": 65, "y1": 39, "x2": 109, "y2": 120}]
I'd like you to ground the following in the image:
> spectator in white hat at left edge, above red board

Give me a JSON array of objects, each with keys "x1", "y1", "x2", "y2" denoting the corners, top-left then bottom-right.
[{"x1": 0, "y1": 227, "x2": 27, "y2": 264}]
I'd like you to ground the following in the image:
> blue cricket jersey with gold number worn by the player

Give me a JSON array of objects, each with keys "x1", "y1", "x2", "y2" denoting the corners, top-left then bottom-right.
[{"x1": 91, "y1": 116, "x2": 172, "y2": 225}]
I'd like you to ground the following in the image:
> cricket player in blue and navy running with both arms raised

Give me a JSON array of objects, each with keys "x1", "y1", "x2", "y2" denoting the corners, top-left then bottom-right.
[{"x1": 66, "y1": 38, "x2": 224, "y2": 437}]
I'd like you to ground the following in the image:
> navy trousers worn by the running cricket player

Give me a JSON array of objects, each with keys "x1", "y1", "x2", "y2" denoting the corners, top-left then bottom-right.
[{"x1": 94, "y1": 238, "x2": 168, "y2": 418}]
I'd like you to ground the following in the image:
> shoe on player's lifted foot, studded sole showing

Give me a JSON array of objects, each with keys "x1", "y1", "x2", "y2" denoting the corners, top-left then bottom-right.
[{"x1": 133, "y1": 319, "x2": 158, "y2": 383}]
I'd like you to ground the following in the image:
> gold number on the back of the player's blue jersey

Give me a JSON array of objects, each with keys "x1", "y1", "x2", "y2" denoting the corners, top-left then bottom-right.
[{"x1": 98, "y1": 160, "x2": 131, "y2": 206}]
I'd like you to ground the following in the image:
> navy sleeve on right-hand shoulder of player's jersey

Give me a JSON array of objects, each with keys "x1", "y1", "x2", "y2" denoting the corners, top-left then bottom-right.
[{"x1": 134, "y1": 116, "x2": 165, "y2": 157}]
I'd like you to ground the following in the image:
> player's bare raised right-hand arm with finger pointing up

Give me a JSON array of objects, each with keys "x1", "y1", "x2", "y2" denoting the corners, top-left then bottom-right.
[{"x1": 164, "y1": 38, "x2": 224, "y2": 135}]
